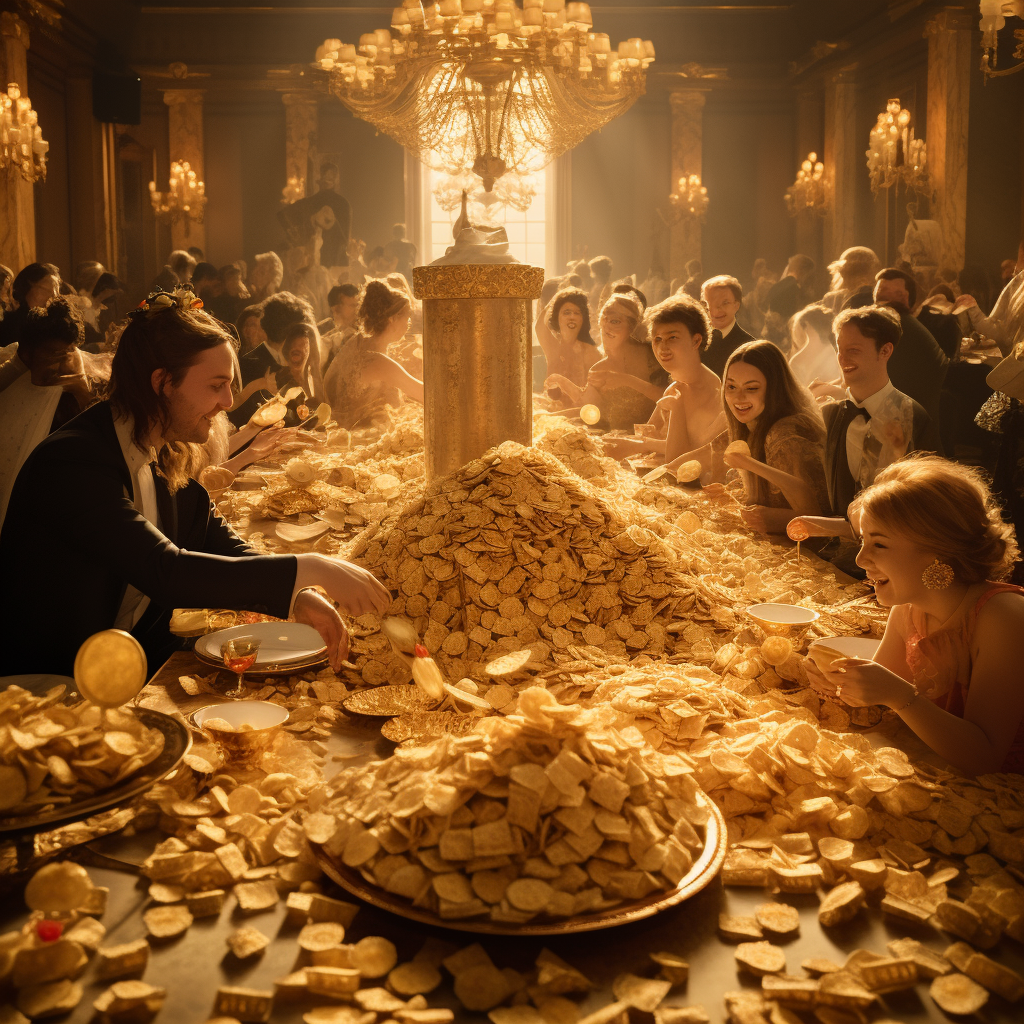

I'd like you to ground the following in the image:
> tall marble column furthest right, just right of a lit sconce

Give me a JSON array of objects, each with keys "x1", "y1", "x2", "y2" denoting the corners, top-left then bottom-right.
[{"x1": 925, "y1": 8, "x2": 974, "y2": 270}]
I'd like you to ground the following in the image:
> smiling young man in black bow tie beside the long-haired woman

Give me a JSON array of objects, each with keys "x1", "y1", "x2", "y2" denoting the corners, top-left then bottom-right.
[{"x1": 786, "y1": 306, "x2": 937, "y2": 575}]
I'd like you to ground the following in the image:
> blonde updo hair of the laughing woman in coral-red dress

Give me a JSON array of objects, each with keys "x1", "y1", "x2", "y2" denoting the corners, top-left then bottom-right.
[{"x1": 850, "y1": 456, "x2": 1020, "y2": 585}]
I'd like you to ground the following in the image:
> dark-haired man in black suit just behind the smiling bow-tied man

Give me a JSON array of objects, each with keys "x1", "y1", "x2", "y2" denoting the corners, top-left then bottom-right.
[{"x1": 874, "y1": 267, "x2": 949, "y2": 430}]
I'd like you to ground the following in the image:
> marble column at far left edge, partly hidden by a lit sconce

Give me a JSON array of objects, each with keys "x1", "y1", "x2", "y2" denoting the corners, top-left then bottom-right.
[{"x1": 0, "y1": 11, "x2": 35, "y2": 273}]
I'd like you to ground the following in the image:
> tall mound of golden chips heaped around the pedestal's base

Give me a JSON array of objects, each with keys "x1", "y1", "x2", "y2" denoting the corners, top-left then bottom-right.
[{"x1": 350, "y1": 441, "x2": 693, "y2": 684}]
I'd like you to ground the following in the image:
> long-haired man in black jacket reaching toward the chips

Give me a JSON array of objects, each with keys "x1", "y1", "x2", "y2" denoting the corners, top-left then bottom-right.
[{"x1": 0, "y1": 293, "x2": 390, "y2": 675}]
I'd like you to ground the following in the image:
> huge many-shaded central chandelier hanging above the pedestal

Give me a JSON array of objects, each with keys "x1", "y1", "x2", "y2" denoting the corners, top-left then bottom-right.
[{"x1": 316, "y1": 0, "x2": 654, "y2": 193}]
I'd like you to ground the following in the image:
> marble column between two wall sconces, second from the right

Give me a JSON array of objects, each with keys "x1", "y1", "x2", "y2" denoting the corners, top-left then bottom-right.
[{"x1": 823, "y1": 67, "x2": 867, "y2": 261}]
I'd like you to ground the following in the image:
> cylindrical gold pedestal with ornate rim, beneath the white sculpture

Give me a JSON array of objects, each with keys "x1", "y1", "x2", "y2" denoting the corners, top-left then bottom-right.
[{"x1": 413, "y1": 263, "x2": 544, "y2": 482}]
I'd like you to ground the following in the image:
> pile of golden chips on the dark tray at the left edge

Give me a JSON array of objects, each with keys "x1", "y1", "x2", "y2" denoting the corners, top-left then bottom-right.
[{"x1": 0, "y1": 686, "x2": 164, "y2": 816}]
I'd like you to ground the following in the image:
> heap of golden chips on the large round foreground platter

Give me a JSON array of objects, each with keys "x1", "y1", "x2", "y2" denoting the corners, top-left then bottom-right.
[{"x1": 315, "y1": 687, "x2": 709, "y2": 924}]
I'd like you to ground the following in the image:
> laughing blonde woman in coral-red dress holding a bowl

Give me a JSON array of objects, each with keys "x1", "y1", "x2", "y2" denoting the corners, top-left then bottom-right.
[{"x1": 794, "y1": 456, "x2": 1024, "y2": 775}]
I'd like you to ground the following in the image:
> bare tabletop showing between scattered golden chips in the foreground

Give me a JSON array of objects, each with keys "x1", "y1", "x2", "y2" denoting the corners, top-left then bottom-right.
[{"x1": 0, "y1": 653, "x2": 1024, "y2": 1024}]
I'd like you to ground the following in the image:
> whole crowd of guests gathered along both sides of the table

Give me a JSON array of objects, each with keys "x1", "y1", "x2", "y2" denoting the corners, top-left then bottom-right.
[{"x1": 0, "y1": 235, "x2": 1024, "y2": 771}]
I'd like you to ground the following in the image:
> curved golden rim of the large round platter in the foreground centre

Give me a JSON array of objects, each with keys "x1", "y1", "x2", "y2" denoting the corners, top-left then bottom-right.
[{"x1": 310, "y1": 800, "x2": 728, "y2": 935}]
